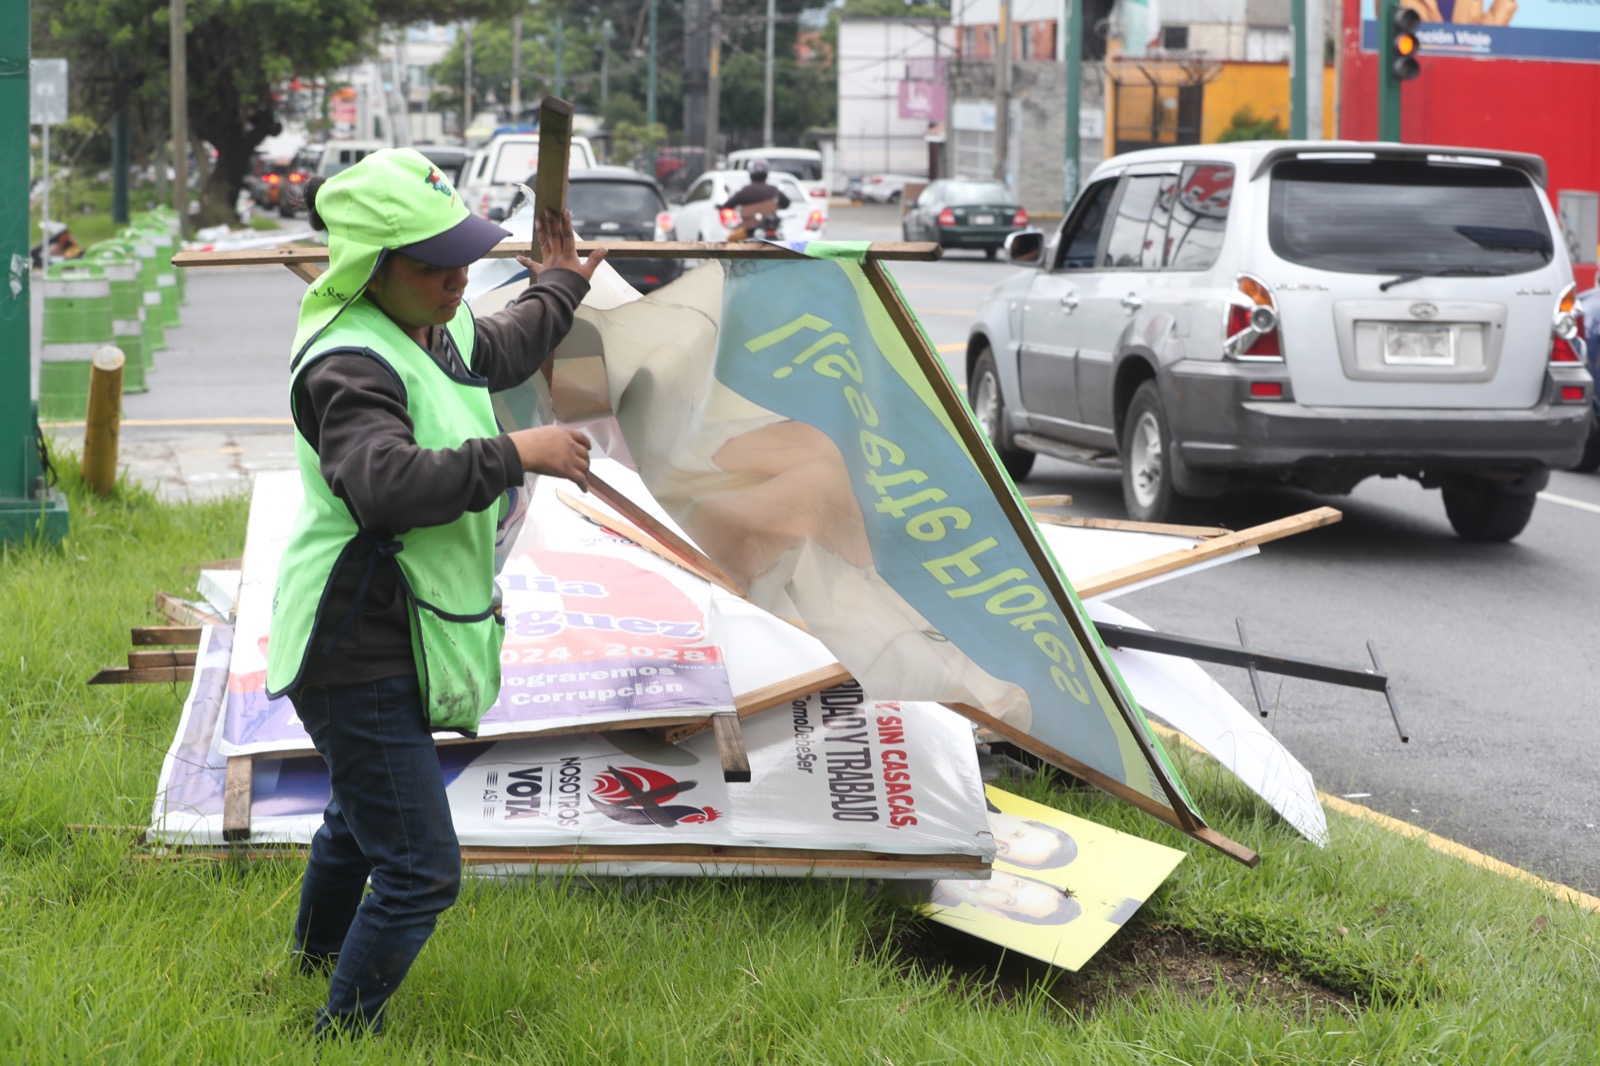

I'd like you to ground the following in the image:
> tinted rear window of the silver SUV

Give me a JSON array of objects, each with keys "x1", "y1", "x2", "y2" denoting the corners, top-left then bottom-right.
[{"x1": 1267, "y1": 158, "x2": 1554, "y2": 275}]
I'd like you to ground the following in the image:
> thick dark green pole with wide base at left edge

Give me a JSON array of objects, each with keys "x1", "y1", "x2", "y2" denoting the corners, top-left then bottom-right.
[{"x1": 0, "y1": 3, "x2": 67, "y2": 543}]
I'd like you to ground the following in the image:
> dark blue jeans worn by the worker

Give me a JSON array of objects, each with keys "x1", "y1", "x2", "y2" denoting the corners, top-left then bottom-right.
[{"x1": 291, "y1": 677, "x2": 461, "y2": 1032}]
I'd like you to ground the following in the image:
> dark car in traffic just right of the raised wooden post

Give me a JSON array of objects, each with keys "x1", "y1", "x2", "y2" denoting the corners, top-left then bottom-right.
[{"x1": 540, "y1": 166, "x2": 683, "y2": 293}]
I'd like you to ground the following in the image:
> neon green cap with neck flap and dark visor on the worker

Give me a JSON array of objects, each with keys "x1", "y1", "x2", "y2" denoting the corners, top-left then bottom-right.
[{"x1": 294, "y1": 149, "x2": 510, "y2": 362}]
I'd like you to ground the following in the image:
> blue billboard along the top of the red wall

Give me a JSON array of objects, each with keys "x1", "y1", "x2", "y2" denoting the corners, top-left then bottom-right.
[{"x1": 1362, "y1": 0, "x2": 1600, "y2": 62}]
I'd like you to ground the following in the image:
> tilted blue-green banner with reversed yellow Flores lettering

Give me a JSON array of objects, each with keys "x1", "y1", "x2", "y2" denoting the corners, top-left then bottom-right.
[{"x1": 576, "y1": 259, "x2": 1181, "y2": 810}]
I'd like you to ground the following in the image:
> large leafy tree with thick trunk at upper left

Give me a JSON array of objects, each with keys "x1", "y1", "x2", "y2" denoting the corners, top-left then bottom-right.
[{"x1": 32, "y1": 0, "x2": 522, "y2": 226}]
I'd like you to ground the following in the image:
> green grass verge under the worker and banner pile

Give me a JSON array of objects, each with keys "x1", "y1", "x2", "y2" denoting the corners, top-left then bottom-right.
[{"x1": 0, "y1": 458, "x2": 1600, "y2": 1066}]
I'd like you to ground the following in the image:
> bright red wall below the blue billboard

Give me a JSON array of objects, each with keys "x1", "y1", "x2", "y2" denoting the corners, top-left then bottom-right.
[{"x1": 1339, "y1": 0, "x2": 1600, "y2": 288}]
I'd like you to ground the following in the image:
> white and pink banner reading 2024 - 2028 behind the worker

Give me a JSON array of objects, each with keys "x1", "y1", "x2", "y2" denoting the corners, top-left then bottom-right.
[{"x1": 222, "y1": 469, "x2": 733, "y2": 755}]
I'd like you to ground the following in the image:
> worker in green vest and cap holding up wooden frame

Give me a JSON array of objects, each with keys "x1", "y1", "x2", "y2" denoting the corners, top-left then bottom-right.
[{"x1": 267, "y1": 149, "x2": 603, "y2": 1034}]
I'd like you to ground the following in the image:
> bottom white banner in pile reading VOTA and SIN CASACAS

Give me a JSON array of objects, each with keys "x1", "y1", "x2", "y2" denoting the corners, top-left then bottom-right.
[{"x1": 152, "y1": 640, "x2": 994, "y2": 877}]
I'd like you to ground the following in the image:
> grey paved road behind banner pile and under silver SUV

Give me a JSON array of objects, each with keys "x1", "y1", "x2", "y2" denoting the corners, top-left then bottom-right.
[{"x1": 46, "y1": 208, "x2": 1600, "y2": 893}]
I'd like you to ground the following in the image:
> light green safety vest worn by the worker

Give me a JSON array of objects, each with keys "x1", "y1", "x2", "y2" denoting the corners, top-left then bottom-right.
[{"x1": 267, "y1": 298, "x2": 506, "y2": 733}]
